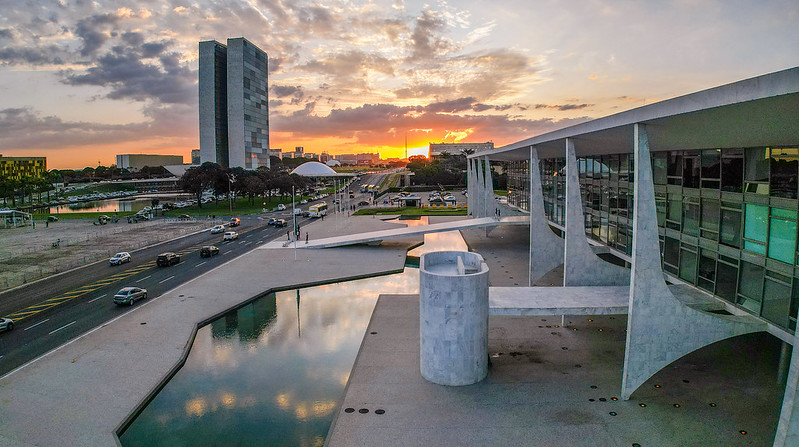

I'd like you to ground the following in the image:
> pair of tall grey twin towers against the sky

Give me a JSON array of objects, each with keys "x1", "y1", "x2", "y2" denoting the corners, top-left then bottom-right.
[{"x1": 199, "y1": 37, "x2": 269, "y2": 169}]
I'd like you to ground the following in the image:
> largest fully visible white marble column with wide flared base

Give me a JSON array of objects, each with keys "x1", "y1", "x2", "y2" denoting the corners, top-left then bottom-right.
[{"x1": 621, "y1": 124, "x2": 766, "y2": 400}]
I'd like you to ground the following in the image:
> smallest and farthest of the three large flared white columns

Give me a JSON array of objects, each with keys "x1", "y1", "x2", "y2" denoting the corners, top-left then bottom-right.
[{"x1": 528, "y1": 146, "x2": 564, "y2": 287}]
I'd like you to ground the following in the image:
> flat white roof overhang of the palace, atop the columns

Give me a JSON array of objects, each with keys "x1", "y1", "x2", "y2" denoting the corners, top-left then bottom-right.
[{"x1": 476, "y1": 67, "x2": 799, "y2": 161}]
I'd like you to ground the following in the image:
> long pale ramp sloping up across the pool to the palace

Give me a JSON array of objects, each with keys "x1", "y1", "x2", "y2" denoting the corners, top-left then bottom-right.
[{"x1": 259, "y1": 216, "x2": 530, "y2": 248}]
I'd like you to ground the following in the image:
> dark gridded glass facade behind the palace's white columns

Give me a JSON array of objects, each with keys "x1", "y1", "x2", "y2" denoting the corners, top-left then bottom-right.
[{"x1": 508, "y1": 147, "x2": 799, "y2": 331}]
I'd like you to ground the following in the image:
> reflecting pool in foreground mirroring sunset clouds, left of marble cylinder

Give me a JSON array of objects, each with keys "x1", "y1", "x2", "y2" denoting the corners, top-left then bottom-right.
[{"x1": 121, "y1": 269, "x2": 419, "y2": 447}]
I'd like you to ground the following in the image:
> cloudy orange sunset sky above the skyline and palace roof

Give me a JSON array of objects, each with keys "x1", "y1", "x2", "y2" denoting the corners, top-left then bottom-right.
[{"x1": 0, "y1": 0, "x2": 799, "y2": 169}]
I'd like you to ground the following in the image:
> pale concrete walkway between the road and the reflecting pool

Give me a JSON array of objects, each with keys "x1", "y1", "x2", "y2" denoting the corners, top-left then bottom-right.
[{"x1": 0, "y1": 217, "x2": 421, "y2": 447}]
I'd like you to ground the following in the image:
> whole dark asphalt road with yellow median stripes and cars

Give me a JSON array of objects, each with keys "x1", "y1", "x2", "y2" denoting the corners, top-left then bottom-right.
[{"x1": 0, "y1": 174, "x2": 382, "y2": 376}]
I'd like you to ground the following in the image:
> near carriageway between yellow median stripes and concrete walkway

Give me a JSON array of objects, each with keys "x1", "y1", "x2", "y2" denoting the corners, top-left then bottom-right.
[{"x1": 0, "y1": 220, "x2": 288, "y2": 375}]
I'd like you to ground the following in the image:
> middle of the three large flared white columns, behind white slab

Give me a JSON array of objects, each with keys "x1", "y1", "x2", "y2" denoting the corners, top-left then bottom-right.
[{"x1": 563, "y1": 138, "x2": 632, "y2": 286}]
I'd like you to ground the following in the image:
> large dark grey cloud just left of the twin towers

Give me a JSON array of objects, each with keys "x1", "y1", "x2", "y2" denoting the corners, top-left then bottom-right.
[{"x1": 62, "y1": 47, "x2": 197, "y2": 104}]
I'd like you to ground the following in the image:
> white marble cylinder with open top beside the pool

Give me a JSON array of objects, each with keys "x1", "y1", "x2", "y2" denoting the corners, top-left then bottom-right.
[{"x1": 419, "y1": 251, "x2": 488, "y2": 386}]
